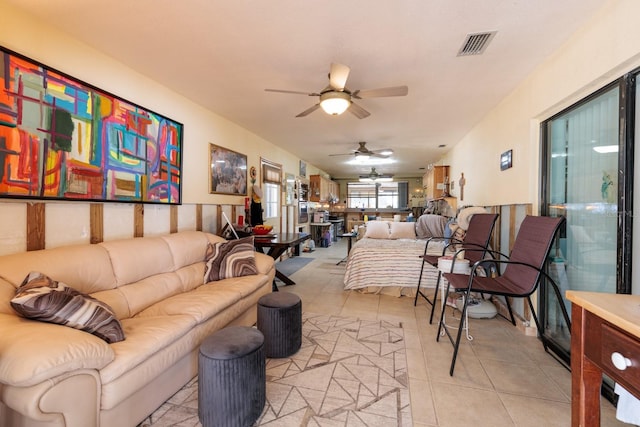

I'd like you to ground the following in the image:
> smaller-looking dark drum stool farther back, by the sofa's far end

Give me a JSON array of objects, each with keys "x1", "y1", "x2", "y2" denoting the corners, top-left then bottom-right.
[{"x1": 258, "y1": 292, "x2": 302, "y2": 358}]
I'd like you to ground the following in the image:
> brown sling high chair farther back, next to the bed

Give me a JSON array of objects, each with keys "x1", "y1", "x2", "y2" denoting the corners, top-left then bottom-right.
[{"x1": 413, "y1": 213, "x2": 498, "y2": 324}]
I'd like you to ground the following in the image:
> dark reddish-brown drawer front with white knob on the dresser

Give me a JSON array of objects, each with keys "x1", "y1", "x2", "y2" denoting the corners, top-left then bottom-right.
[{"x1": 600, "y1": 323, "x2": 640, "y2": 390}]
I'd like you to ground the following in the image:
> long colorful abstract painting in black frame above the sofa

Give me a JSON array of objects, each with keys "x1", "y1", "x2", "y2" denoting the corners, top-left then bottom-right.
[{"x1": 0, "y1": 48, "x2": 182, "y2": 204}]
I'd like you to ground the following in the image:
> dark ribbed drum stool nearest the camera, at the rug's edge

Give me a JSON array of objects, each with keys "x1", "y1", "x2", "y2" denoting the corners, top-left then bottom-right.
[{"x1": 198, "y1": 326, "x2": 266, "y2": 427}]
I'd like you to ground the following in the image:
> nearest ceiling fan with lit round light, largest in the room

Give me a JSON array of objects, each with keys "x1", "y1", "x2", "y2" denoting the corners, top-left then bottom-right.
[{"x1": 265, "y1": 63, "x2": 409, "y2": 119}]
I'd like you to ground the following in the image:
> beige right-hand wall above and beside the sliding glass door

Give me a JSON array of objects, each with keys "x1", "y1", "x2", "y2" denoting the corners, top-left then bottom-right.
[{"x1": 445, "y1": 0, "x2": 640, "y2": 213}]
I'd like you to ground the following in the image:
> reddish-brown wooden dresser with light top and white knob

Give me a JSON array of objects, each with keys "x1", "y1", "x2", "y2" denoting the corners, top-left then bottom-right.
[{"x1": 567, "y1": 291, "x2": 640, "y2": 427}]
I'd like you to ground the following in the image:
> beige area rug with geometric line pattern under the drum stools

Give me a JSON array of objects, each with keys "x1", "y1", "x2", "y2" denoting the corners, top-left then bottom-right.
[{"x1": 141, "y1": 313, "x2": 412, "y2": 427}]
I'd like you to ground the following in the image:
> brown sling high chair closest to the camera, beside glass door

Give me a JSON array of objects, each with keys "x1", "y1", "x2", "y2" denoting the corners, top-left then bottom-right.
[{"x1": 436, "y1": 215, "x2": 571, "y2": 376}]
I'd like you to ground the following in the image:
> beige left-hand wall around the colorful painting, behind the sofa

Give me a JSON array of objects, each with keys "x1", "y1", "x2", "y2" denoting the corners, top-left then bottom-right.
[{"x1": 0, "y1": 5, "x2": 319, "y2": 254}]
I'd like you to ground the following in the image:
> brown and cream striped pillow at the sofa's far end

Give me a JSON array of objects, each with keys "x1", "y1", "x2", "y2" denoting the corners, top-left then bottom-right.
[{"x1": 204, "y1": 236, "x2": 258, "y2": 283}]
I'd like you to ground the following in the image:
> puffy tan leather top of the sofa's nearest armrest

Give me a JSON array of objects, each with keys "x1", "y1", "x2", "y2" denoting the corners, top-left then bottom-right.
[{"x1": 0, "y1": 313, "x2": 115, "y2": 387}]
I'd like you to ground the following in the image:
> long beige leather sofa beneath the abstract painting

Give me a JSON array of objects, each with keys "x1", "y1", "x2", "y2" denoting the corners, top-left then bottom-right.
[{"x1": 0, "y1": 231, "x2": 275, "y2": 427}]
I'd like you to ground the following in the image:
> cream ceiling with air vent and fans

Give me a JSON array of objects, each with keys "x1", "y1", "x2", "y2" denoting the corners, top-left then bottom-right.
[{"x1": 0, "y1": 0, "x2": 606, "y2": 178}]
